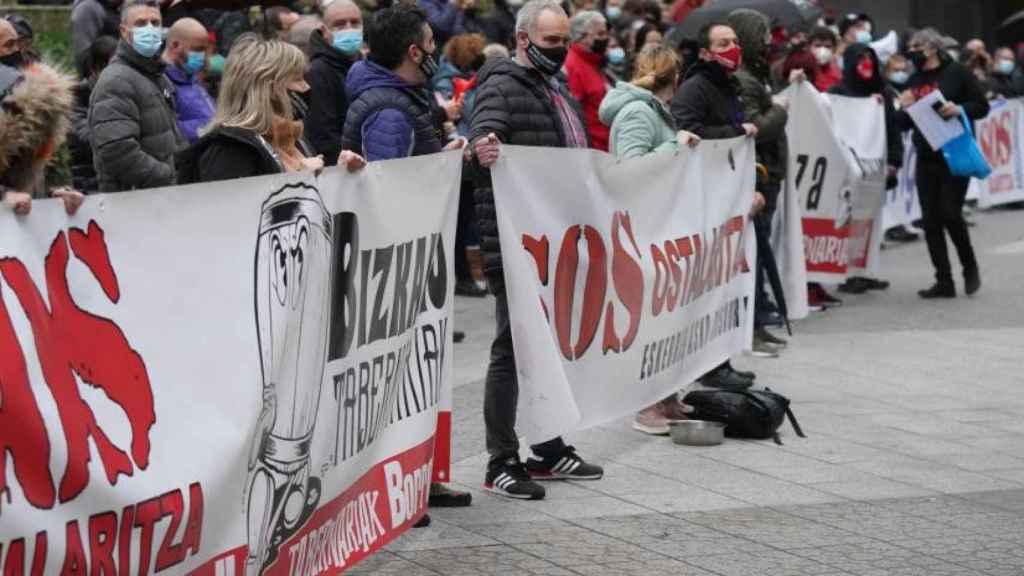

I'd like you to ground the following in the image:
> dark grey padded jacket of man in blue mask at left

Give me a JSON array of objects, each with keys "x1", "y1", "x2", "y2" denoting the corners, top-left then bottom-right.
[{"x1": 89, "y1": 41, "x2": 187, "y2": 192}]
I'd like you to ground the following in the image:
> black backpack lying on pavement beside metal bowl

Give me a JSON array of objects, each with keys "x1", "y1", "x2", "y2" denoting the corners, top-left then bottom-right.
[{"x1": 683, "y1": 388, "x2": 807, "y2": 445}]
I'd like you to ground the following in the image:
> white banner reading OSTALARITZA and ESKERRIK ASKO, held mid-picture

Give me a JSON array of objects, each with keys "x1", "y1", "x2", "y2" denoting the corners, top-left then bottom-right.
[{"x1": 492, "y1": 138, "x2": 756, "y2": 442}]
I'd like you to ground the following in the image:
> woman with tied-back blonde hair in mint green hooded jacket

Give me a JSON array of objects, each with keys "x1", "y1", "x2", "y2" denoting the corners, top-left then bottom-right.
[{"x1": 598, "y1": 46, "x2": 700, "y2": 435}]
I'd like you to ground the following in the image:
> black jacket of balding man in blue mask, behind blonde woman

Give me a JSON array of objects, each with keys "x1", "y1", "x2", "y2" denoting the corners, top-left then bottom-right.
[{"x1": 305, "y1": 32, "x2": 355, "y2": 166}]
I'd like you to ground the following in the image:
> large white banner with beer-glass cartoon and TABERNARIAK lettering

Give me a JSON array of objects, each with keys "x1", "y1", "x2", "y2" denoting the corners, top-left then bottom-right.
[{"x1": 0, "y1": 153, "x2": 462, "y2": 576}]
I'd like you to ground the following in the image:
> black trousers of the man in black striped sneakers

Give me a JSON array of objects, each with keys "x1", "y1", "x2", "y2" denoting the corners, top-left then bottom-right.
[{"x1": 483, "y1": 283, "x2": 565, "y2": 461}]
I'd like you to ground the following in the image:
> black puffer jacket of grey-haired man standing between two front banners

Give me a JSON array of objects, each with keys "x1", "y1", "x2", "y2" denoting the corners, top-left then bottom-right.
[{"x1": 469, "y1": 58, "x2": 586, "y2": 282}]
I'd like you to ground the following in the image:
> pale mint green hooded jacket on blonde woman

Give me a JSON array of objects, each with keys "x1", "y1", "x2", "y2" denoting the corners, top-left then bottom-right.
[{"x1": 598, "y1": 82, "x2": 679, "y2": 160}]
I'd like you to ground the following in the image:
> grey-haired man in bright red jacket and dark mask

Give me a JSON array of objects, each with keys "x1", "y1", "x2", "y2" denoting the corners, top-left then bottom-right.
[{"x1": 565, "y1": 10, "x2": 613, "y2": 152}]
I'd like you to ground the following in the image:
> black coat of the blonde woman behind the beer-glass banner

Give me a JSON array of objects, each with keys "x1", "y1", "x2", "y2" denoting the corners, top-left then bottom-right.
[{"x1": 177, "y1": 127, "x2": 286, "y2": 184}]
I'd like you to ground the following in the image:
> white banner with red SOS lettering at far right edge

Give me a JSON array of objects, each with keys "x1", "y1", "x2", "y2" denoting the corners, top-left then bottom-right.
[{"x1": 975, "y1": 99, "x2": 1024, "y2": 207}]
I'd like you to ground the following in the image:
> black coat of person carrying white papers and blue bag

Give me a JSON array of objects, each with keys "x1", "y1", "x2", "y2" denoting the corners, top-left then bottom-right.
[{"x1": 896, "y1": 55, "x2": 988, "y2": 163}]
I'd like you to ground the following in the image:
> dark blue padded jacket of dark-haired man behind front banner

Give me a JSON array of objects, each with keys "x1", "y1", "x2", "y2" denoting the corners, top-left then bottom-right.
[{"x1": 341, "y1": 60, "x2": 443, "y2": 162}]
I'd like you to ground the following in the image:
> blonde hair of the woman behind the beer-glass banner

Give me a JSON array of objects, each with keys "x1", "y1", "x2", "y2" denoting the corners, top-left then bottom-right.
[{"x1": 206, "y1": 36, "x2": 306, "y2": 135}]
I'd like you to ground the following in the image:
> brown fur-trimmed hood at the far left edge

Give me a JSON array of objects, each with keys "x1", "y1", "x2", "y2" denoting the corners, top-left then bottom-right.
[{"x1": 0, "y1": 63, "x2": 75, "y2": 190}]
